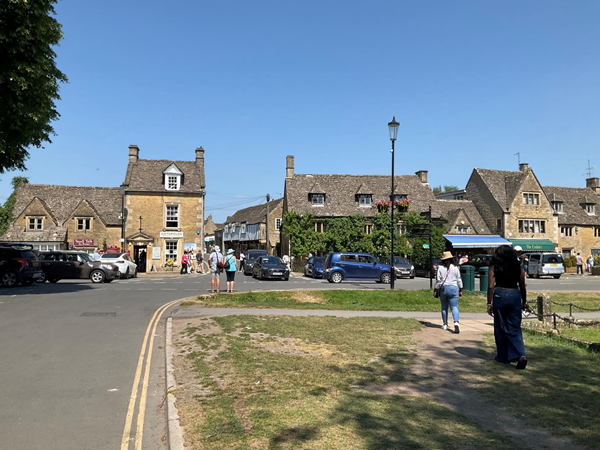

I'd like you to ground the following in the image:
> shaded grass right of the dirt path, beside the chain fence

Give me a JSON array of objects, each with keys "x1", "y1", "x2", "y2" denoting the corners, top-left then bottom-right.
[{"x1": 481, "y1": 332, "x2": 600, "y2": 449}]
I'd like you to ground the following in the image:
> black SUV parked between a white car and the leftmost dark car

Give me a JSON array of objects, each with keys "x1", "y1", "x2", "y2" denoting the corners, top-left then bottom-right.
[{"x1": 40, "y1": 251, "x2": 120, "y2": 283}]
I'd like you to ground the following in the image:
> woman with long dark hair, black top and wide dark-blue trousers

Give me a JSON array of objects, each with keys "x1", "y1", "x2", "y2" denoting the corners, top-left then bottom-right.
[{"x1": 487, "y1": 245, "x2": 527, "y2": 369}]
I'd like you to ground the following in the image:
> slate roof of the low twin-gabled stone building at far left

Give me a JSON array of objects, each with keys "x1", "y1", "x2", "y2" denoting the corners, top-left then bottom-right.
[{"x1": 13, "y1": 183, "x2": 121, "y2": 225}]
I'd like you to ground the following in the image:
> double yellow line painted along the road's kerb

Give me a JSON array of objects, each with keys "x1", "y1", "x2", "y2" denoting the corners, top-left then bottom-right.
[{"x1": 121, "y1": 300, "x2": 180, "y2": 450}]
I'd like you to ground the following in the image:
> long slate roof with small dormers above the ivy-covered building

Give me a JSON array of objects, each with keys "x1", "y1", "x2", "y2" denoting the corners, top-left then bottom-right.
[{"x1": 285, "y1": 174, "x2": 435, "y2": 217}]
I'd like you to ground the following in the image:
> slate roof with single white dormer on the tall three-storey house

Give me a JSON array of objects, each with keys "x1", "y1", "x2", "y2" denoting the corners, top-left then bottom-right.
[{"x1": 123, "y1": 159, "x2": 206, "y2": 193}]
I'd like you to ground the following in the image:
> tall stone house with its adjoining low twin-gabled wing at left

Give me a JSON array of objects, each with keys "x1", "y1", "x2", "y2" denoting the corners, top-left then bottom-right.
[{"x1": 0, "y1": 145, "x2": 205, "y2": 271}]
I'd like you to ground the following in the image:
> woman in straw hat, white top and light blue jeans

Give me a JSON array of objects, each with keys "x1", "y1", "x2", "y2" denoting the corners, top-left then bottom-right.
[{"x1": 434, "y1": 252, "x2": 463, "y2": 334}]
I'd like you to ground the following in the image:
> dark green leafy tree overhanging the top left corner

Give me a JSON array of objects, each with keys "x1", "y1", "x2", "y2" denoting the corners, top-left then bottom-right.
[{"x1": 0, "y1": 0, "x2": 68, "y2": 173}]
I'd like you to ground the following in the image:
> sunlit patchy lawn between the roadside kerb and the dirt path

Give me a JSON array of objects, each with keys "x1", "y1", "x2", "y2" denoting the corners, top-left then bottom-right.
[{"x1": 174, "y1": 316, "x2": 517, "y2": 450}]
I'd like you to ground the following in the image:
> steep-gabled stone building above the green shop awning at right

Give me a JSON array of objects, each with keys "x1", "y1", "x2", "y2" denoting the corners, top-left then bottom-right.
[{"x1": 466, "y1": 164, "x2": 558, "y2": 251}]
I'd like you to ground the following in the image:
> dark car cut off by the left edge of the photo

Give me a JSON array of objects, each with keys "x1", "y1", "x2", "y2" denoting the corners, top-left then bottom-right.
[{"x1": 0, "y1": 244, "x2": 42, "y2": 287}]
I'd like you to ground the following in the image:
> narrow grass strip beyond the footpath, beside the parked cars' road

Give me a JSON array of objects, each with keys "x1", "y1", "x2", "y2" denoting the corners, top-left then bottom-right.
[{"x1": 182, "y1": 289, "x2": 600, "y2": 312}]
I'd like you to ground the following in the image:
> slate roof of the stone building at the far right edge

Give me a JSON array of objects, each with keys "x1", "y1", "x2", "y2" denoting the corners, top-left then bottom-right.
[{"x1": 542, "y1": 186, "x2": 600, "y2": 225}]
